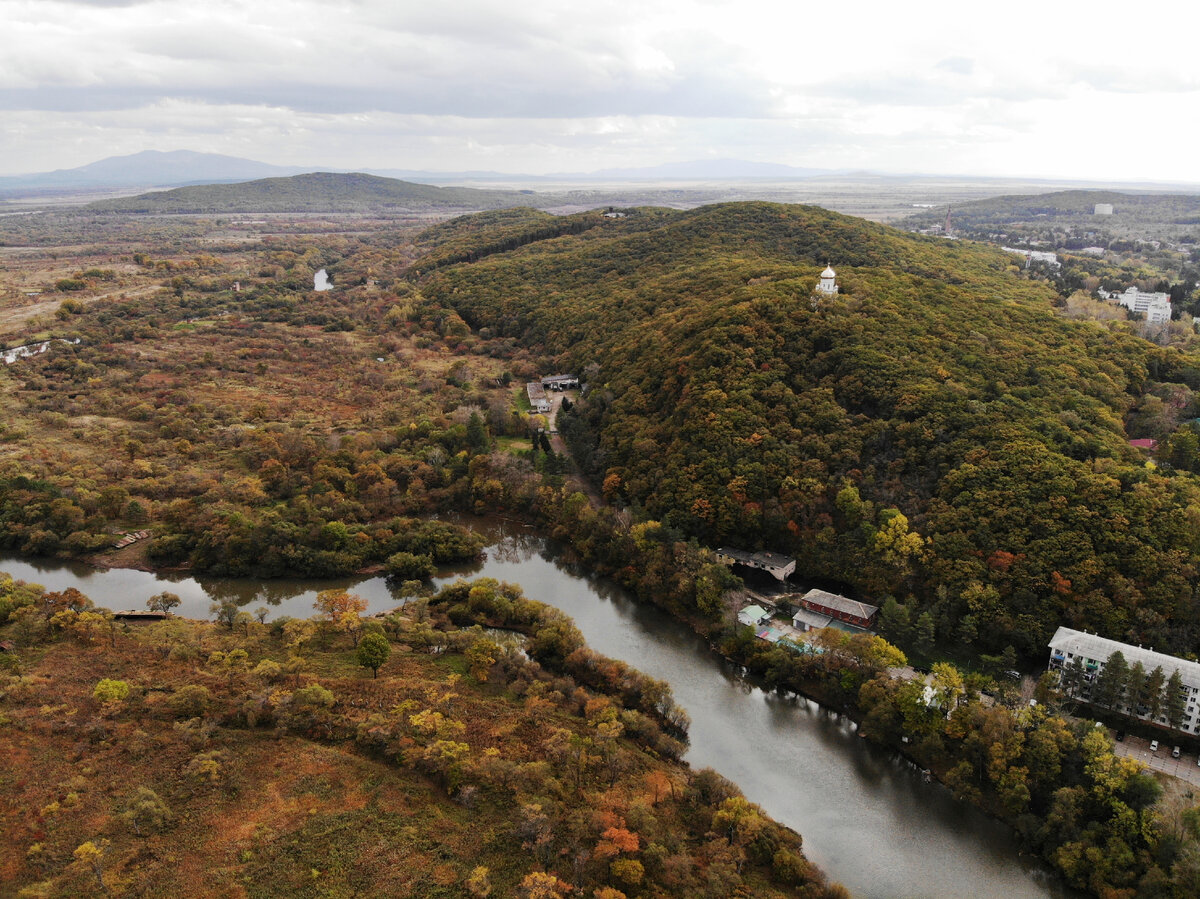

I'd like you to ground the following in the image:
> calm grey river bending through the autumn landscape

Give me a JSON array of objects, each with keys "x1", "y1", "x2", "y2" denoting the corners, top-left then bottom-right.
[{"x1": 0, "y1": 520, "x2": 1069, "y2": 899}]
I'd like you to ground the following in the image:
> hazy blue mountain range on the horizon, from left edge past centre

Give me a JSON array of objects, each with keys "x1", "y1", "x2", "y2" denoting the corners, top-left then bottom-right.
[{"x1": 0, "y1": 150, "x2": 830, "y2": 197}]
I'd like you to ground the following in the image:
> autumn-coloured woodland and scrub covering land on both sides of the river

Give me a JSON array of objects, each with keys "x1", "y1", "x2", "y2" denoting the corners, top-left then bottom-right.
[{"x1": 7, "y1": 179, "x2": 1200, "y2": 899}]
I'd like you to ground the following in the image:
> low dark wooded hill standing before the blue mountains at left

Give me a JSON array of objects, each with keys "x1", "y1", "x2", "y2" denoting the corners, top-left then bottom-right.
[{"x1": 86, "y1": 172, "x2": 542, "y2": 215}]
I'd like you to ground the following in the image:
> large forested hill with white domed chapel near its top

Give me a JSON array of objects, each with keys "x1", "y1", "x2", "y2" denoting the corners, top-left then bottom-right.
[{"x1": 415, "y1": 203, "x2": 1200, "y2": 657}]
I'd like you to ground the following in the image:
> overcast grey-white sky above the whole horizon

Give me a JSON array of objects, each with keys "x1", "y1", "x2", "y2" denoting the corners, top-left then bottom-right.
[{"x1": 0, "y1": 0, "x2": 1200, "y2": 182}]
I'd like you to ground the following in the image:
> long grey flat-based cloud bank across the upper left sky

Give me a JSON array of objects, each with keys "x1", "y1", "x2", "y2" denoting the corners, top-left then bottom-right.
[{"x1": 0, "y1": 2, "x2": 768, "y2": 118}]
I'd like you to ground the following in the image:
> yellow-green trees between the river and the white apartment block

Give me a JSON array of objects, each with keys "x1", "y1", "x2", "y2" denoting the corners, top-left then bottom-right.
[{"x1": 720, "y1": 627, "x2": 1200, "y2": 899}]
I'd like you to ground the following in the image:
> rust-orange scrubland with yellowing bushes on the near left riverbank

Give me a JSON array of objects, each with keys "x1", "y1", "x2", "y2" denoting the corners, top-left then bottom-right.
[{"x1": 0, "y1": 581, "x2": 846, "y2": 899}]
